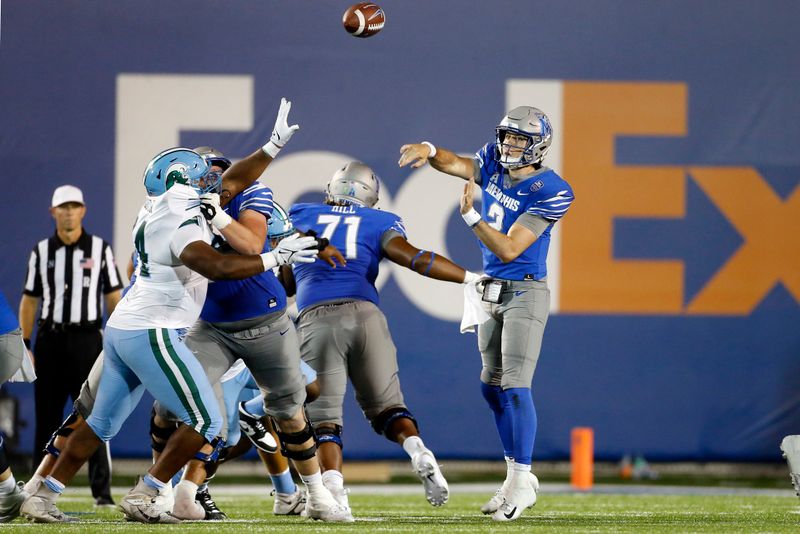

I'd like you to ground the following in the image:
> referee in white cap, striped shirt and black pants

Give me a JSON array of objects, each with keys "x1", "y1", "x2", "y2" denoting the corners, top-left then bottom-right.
[{"x1": 19, "y1": 185, "x2": 122, "y2": 506}]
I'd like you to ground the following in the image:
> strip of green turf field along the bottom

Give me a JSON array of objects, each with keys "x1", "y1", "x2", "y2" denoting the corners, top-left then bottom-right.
[{"x1": 0, "y1": 493, "x2": 800, "y2": 534}]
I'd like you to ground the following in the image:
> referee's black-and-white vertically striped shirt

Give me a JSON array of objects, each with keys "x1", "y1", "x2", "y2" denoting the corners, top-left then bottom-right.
[{"x1": 23, "y1": 231, "x2": 122, "y2": 325}]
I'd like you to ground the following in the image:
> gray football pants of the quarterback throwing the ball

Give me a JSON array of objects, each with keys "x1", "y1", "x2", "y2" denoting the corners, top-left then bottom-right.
[{"x1": 478, "y1": 280, "x2": 550, "y2": 389}]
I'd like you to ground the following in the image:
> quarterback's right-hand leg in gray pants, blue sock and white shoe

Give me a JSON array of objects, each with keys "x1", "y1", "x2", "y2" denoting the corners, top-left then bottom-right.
[{"x1": 492, "y1": 282, "x2": 550, "y2": 521}]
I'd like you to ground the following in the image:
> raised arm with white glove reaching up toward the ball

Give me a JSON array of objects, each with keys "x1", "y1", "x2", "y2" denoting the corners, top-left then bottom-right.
[{"x1": 220, "y1": 98, "x2": 300, "y2": 206}]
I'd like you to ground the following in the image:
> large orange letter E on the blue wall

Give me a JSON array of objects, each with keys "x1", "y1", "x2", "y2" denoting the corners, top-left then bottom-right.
[{"x1": 559, "y1": 82, "x2": 687, "y2": 314}]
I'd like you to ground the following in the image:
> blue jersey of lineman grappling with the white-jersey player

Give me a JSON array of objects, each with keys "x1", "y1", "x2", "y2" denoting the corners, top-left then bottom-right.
[{"x1": 200, "y1": 182, "x2": 286, "y2": 323}]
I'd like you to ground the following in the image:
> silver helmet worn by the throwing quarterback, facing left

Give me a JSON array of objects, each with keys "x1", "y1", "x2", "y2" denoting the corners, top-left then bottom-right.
[{"x1": 495, "y1": 106, "x2": 553, "y2": 169}]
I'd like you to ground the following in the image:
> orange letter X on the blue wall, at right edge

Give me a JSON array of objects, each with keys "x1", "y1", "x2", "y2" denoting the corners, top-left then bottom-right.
[{"x1": 687, "y1": 167, "x2": 800, "y2": 315}]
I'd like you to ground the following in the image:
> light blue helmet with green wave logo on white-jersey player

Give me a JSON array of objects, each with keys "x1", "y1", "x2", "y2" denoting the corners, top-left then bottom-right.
[{"x1": 144, "y1": 147, "x2": 213, "y2": 197}]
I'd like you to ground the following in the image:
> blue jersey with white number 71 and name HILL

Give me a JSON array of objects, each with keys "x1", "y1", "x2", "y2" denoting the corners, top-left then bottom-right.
[{"x1": 289, "y1": 204, "x2": 406, "y2": 311}]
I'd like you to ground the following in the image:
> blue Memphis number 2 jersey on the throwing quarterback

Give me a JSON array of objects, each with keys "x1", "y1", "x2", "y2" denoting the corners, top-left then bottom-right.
[{"x1": 475, "y1": 143, "x2": 575, "y2": 280}]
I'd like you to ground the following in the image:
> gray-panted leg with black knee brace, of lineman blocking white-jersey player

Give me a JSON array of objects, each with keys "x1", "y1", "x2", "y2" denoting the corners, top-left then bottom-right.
[{"x1": 247, "y1": 313, "x2": 353, "y2": 522}]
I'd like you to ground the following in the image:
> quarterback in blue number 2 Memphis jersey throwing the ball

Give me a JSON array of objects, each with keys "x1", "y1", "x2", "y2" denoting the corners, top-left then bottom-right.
[{"x1": 398, "y1": 106, "x2": 575, "y2": 521}]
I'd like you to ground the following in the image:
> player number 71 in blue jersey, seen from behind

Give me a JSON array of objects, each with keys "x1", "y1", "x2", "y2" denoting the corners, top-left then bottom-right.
[{"x1": 289, "y1": 162, "x2": 478, "y2": 520}]
